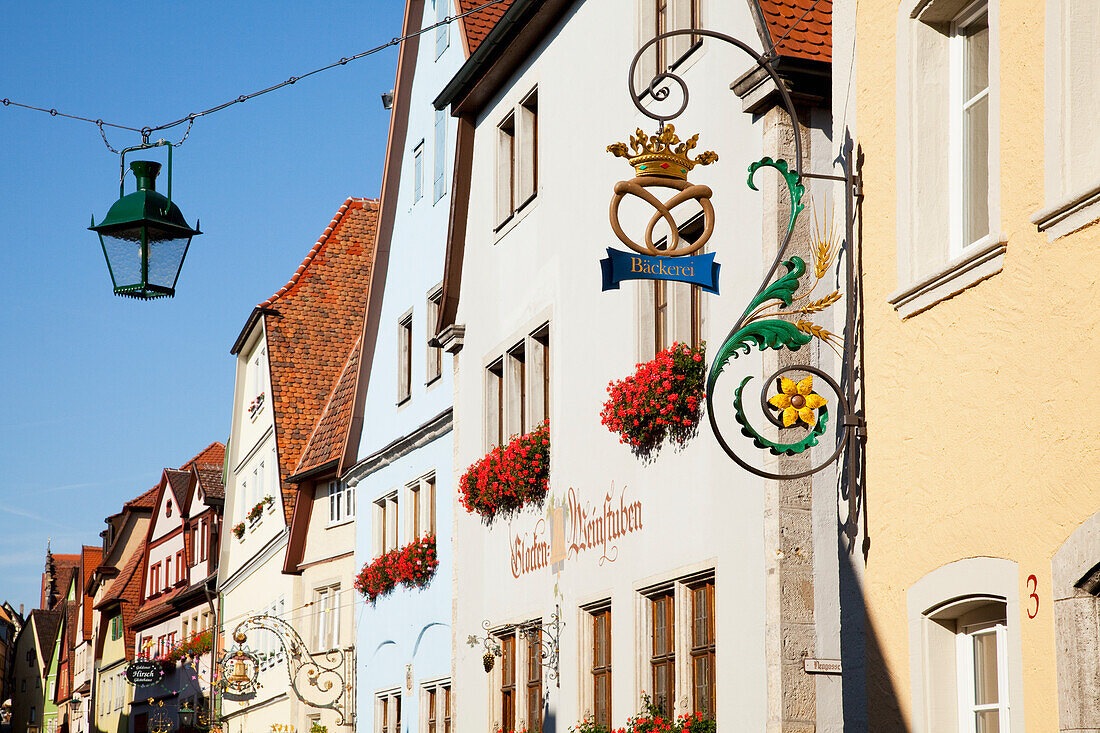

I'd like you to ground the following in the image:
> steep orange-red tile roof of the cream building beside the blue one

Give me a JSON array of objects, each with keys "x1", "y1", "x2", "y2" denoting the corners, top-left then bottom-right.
[{"x1": 261, "y1": 198, "x2": 378, "y2": 524}]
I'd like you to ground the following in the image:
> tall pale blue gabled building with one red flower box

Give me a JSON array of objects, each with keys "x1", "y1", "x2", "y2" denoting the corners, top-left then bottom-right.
[{"x1": 341, "y1": 0, "x2": 468, "y2": 731}]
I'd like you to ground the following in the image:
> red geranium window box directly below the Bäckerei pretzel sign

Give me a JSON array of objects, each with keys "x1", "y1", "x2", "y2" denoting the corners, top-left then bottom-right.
[{"x1": 600, "y1": 343, "x2": 706, "y2": 456}]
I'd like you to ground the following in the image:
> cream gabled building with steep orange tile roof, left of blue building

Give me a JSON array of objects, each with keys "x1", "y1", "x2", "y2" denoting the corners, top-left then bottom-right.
[{"x1": 218, "y1": 198, "x2": 378, "y2": 730}]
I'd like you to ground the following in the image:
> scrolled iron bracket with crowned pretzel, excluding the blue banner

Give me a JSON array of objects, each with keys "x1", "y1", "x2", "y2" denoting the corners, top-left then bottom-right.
[{"x1": 607, "y1": 29, "x2": 865, "y2": 479}]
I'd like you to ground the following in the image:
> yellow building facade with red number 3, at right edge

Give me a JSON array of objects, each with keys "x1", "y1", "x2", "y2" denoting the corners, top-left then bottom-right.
[{"x1": 834, "y1": 0, "x2": 1100, "y2": 733}]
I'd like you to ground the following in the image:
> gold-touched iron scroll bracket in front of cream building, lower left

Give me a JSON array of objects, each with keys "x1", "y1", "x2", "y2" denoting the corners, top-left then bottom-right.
[{"x1": 233, "y1": 615, "x2": 354, "y2": 725}]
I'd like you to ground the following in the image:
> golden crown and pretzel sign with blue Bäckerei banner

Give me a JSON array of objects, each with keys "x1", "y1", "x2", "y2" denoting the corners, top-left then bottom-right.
[{"x1": 600, "y1": 124, "x2": 721, "y2": 294}]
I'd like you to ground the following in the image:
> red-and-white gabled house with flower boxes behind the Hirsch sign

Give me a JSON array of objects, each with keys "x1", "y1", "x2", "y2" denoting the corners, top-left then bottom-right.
[{"x1": 128, "y1": 442, "x2": 226, "y2": 733}]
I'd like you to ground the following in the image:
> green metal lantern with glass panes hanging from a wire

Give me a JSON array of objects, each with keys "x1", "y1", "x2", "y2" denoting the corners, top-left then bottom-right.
[{"x1": 88, "y1": 146, "x2": 202, "y2": 300}]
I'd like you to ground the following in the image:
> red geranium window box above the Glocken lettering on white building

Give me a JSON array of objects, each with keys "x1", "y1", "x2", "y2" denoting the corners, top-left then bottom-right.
[{"x1": 459, "y1": 420, "x2": 550, "y2": 524}]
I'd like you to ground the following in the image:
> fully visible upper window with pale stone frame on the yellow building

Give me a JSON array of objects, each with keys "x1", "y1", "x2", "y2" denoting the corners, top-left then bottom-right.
[{"x1": 888, "y1": 0, "x2": 1008, "y2": 318}]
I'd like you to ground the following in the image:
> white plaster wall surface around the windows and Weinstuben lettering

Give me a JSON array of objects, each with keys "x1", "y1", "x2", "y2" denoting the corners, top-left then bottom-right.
[{"x1": 446, "y1": 0, "x2": 783, "y2": 730}]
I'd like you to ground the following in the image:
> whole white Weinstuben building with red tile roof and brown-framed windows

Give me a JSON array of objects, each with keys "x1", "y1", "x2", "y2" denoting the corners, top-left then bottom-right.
[{"x1": 433, "y1": 0, "x2": 850, "y2": 733}]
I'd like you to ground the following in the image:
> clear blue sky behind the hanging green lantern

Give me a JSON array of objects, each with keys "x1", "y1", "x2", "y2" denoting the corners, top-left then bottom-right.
[{"x1": 0, "y1": 0, "x2": 404, "y2": 610}]
